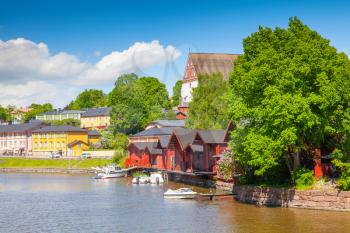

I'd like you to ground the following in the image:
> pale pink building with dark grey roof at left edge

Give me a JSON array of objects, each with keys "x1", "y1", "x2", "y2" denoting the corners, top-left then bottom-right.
[{"x1": 0, "y1": 121, "x2": 48, "y2": 155}]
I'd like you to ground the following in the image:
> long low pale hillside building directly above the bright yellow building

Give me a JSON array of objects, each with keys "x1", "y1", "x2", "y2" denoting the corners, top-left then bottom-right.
[{"x1": 35, "y1": 109, "x2": 85, "y2": 121}]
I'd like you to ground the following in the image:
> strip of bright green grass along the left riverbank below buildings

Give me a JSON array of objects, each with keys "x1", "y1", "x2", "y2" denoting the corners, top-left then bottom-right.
[{"x1": 0, "y1": 158, "x2": 111, "y2": 169}]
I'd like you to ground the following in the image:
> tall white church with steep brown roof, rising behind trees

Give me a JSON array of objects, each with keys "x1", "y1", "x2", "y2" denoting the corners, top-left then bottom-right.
[{"x1": 177, "y1": 53, "x2": 240, "y2": 119}]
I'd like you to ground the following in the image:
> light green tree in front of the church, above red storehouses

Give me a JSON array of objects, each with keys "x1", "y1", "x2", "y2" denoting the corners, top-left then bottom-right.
[{"x1": 186, "y1": 74, "x2": 229, "y2": 129}]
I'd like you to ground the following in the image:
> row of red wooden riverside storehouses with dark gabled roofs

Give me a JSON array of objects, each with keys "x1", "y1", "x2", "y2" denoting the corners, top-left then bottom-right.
[{"x1": 126, "y1": 124, "x2": 233, "y2": 174}]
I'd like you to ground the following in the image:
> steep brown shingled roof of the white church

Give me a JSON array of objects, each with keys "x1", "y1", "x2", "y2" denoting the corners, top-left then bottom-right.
[{"x1": 189, "y1": 53, "x2": 240, "y2": 80}]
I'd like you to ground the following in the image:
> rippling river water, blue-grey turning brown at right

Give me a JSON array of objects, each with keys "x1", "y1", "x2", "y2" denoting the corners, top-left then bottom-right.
[{"x1": 0, "y1": 173, "x2": 350, "y2": 233}]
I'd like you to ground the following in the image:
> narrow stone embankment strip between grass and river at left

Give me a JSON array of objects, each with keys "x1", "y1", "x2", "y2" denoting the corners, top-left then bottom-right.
[{"x1": 0, "y1": 168, "x2": 94, "y2": 174}]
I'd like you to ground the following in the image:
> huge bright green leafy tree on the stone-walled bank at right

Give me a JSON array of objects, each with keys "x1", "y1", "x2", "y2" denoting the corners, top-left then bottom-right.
[{"x1": 230, "y1": 18, "x2": 350, "y2": 176}]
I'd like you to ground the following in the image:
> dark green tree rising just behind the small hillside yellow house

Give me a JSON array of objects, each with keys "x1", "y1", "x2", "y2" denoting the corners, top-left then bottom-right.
[{"x1": 68, "y1": 89, "x2": 107, "y2": 110}]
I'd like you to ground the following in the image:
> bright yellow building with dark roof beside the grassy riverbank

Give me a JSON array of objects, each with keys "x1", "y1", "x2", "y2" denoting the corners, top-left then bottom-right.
[{"x1": 32, "y1": 125, "x2": 88, "y2": 156}]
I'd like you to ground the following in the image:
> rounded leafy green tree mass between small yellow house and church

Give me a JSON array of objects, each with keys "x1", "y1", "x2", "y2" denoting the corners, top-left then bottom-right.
[{"x1": 108, "y1": 74, "x2": 170, "y2": 134}]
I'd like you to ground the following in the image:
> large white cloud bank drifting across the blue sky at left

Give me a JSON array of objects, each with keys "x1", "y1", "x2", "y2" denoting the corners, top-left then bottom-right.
[{"x1": 0, "y1": 38, "x2": 181, "y2": 106}]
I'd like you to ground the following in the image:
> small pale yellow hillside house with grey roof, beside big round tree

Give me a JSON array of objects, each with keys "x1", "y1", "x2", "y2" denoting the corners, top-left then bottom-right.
[{"x1": 80, "y1": 108, "x2": 111, "y2": 129}]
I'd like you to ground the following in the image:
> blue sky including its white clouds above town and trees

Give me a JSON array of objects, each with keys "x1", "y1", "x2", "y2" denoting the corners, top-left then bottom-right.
[{"x1": 0, "y1": 0, "x2": 350, "y2": 108}]
